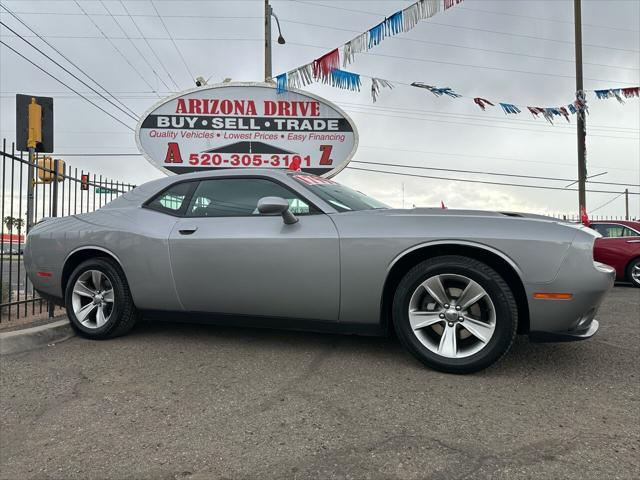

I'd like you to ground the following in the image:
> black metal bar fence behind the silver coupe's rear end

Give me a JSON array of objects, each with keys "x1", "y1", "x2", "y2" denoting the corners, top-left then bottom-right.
[{"x1": 0, "y1": 140, "x2": 135, "y2": 322}]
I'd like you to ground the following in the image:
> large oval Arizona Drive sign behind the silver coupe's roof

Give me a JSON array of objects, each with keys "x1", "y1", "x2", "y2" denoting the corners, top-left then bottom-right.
[{"x1": 136, "y1": 83, "x2": 358, "y2": 177}]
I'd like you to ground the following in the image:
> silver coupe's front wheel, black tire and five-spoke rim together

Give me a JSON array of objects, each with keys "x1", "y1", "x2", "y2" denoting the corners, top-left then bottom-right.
[{"x1": 393, "y1": 255, "x2": 518, "y2": 373}]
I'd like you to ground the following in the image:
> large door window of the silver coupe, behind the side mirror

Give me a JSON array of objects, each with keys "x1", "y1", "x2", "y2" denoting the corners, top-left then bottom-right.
[{"x1": 186, "y1": 178, "x2": 317, "y2": 217}]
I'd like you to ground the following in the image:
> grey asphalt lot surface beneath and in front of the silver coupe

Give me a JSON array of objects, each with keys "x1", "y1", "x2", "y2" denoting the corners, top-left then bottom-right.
[{"x1": 0, "y1": 286, "x2": 640, "y2": 480}]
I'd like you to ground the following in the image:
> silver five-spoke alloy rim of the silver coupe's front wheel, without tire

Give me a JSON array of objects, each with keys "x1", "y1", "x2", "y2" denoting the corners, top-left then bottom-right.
[{"x1": 409, "y1": 274, "x2": 496, "y2": 358}]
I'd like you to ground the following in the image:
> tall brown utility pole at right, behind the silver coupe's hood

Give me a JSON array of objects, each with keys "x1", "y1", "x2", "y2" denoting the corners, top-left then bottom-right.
[{"x1": 573, "y1": 0, "x2": 587, "y2": 215}]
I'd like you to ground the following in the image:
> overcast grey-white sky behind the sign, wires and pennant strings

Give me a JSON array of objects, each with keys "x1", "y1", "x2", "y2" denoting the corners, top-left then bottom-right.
[{"x1": 0, "y1": 0, "x2": 640, "y2": 217}]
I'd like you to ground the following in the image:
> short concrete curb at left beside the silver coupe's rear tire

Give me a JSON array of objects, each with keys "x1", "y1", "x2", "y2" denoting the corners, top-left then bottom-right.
[{"x1": 0, "y1": 318, "x2": 75, "y2": 355}]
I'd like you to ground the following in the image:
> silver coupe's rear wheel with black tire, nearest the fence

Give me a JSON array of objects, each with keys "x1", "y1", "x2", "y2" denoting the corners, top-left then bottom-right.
[{"x1": 65, "y1": 258, "x2": 137, "y2": 340}]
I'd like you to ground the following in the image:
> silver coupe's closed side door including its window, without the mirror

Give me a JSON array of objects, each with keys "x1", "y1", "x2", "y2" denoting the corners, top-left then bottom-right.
[{"x1": 169, "y1": 176, "x2": 340, "y2": 321}]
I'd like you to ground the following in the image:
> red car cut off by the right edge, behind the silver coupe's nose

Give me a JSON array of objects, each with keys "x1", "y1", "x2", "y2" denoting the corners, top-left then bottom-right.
[{"x1": 589, "y1": 220, "x2": 640, "y2": 287}]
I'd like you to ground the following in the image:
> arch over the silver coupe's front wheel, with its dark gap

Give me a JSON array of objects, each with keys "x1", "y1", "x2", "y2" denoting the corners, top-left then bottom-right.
[{"x1": 380, "y1": 241, "x2": 529, "y2": 333}]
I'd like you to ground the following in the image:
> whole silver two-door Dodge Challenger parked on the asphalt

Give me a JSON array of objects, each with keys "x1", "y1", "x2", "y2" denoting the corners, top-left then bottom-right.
[{"x1": 24, "y1": 169, "x2": 615, "y2": 373}]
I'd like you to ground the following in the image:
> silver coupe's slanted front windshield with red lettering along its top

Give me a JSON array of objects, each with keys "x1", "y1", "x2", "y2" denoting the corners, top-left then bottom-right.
[{"x1": 293, "y1": 174, "x2": 389, "y2": 212}]
